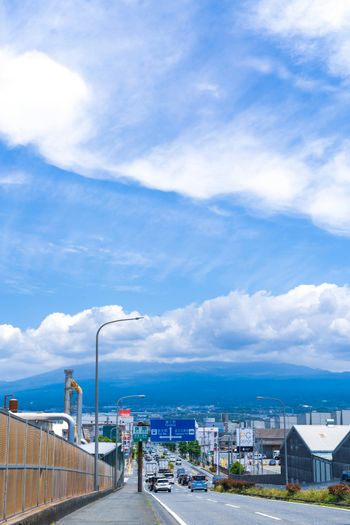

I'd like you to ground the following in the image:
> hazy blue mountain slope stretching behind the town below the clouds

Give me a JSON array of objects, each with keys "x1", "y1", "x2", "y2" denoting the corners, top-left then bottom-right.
[{"x1": 0, "y1": 362, "x2": 350, "y2": 410}]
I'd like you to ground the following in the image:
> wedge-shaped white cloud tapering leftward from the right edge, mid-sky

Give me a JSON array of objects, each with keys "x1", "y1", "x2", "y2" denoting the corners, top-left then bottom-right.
[{"x1": 113, "y1": 121, "x2": 350, "y2": 235}]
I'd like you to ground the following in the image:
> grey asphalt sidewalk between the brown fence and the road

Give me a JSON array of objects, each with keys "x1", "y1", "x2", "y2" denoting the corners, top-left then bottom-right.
[{"x1": 57, "y1": 475, "x2": 161, "y2": 525}]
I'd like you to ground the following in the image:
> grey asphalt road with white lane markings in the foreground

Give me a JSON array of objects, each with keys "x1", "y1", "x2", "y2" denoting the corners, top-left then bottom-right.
[{"x1": 146, "y1": 456, "x2": 350, "y2": 525}]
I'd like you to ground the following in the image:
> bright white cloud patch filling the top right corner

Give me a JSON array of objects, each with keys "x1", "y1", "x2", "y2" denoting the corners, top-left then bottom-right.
[{"x1": 251, "y1": 0, "x2": 350, "y2": 76}]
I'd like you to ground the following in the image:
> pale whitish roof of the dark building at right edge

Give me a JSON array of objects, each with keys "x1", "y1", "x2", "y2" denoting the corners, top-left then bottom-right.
[{"x1": 294, "y1": 425, "x2": 350, "y2": 453}]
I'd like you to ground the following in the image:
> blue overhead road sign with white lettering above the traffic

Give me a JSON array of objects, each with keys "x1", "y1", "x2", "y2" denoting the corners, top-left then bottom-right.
[{"x1": 150, "y1": 419, "x2": 196, "y2": 443}]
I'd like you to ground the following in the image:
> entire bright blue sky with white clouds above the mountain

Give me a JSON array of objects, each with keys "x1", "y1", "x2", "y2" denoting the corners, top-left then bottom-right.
[{"x1": 0, "y1": 0, "x2": 350, "y2": 380}]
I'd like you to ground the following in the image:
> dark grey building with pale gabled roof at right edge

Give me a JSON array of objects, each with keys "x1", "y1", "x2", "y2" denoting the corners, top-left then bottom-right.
[{"x1": 281, "y1": 425, "x2": 350, "y2": 483}]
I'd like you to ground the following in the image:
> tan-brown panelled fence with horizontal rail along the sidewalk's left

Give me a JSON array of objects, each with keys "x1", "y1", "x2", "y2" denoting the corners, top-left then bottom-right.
[{"x1": 0, "y1": 411, "x2": 114, "y2": 523}]
